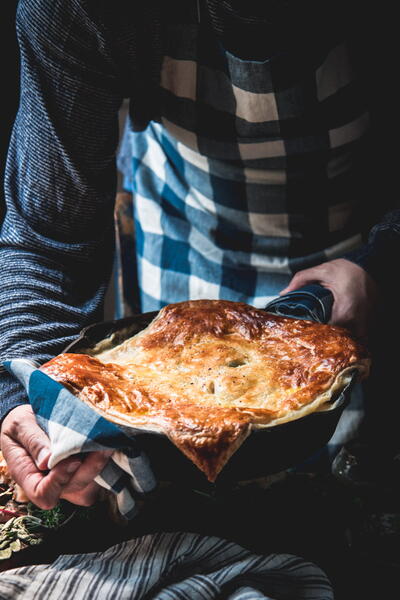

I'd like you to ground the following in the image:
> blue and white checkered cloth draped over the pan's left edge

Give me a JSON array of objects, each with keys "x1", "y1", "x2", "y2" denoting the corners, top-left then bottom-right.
[{"x1": 4, "y1": 358, "x2": 156, "y2": 519}]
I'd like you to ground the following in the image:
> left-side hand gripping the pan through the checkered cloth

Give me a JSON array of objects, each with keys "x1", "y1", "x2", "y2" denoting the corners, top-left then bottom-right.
[{"x1": 0, "y1": 404, "x2": 111, "y2": 510}]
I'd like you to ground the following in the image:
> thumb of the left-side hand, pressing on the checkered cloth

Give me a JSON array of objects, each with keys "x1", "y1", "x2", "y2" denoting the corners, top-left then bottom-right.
[{"x1": 7, "y1": 406, "x2": 50, "y2": 470}]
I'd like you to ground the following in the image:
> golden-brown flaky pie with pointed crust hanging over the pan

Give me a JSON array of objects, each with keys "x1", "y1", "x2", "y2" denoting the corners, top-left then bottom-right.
[{"x1": 41, "y1": 300, "x2": 369, "y2": 481}]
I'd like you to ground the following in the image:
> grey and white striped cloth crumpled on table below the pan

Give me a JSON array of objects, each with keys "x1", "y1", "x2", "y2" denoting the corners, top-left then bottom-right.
[{"x1": 0, "y1": 533, "x2": 333, "y2": 600}]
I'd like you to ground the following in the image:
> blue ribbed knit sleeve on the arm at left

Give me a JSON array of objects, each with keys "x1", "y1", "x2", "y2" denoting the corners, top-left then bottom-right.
[{"x1": 0, "y1": 0, "x2": 123, "y2": 418}]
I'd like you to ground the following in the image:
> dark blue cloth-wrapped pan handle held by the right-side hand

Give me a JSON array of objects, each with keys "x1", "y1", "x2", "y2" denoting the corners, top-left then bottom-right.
[{"x1": 264, "y1": 283, "x2": 333, "y2": 323}]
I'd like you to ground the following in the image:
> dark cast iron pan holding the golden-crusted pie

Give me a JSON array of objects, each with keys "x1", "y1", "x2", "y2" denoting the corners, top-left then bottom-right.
[{"x1": 64, "y1": 290, "x2": 355, "y2": 486}]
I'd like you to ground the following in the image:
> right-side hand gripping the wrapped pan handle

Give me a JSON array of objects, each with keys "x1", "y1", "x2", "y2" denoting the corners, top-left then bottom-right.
[{"x1": 280, "y1": 258, "x2": 378, "y2": 338}]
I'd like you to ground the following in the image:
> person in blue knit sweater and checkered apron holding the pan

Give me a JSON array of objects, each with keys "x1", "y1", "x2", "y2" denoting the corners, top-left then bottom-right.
[{"x1": 0, "y1": 0, "x2": 400, "y2": 508}]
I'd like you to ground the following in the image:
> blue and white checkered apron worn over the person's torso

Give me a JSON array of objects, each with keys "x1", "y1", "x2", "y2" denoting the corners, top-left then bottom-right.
[{"x1": 119, "y1": 3, "x2": 368, "y2": 311}]
